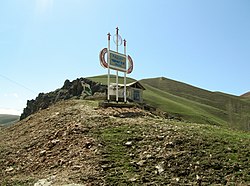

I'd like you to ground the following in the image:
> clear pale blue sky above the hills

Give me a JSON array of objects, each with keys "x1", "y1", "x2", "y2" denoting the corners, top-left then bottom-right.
[{"x1": 0, "y1": 0, "x2": 250, "y2": 114}]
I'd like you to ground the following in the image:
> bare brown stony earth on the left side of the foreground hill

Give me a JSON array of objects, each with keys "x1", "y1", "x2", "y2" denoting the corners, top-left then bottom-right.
[{"x1": 0, "y1": 100, "x2": 152, "y2": 185}]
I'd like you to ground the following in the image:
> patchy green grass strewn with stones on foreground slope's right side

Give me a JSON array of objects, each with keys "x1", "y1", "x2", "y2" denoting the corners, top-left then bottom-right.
[{"x1": 96, "y1": 117, "x2": 250, "y2": 185}]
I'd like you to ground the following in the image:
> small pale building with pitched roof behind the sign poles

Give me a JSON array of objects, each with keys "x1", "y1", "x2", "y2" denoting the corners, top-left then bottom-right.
[{"x1": 110, "y1": 81, "x2": 145, "y2": 103}]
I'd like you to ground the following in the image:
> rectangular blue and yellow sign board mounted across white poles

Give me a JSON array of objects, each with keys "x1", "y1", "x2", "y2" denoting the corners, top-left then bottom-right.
[{"x1": 109, "y1": 50, "x2": 127, "y2": 72}]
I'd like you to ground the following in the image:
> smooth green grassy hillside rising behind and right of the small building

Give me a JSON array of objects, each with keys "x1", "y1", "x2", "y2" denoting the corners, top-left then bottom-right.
[{"x1": 140, "y1": 77, "x2": 250, "y2": 130}]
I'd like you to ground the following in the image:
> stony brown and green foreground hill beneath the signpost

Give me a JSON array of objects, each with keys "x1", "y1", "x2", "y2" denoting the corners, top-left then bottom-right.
[{"x1": 0, "y1": 99, "x2": 250, "y2": 185}]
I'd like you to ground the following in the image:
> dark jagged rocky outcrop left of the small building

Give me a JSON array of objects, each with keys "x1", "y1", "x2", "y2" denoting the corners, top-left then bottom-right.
[{"x1": 20, "y1": 78, "x2": 107, "y2": 120}]
